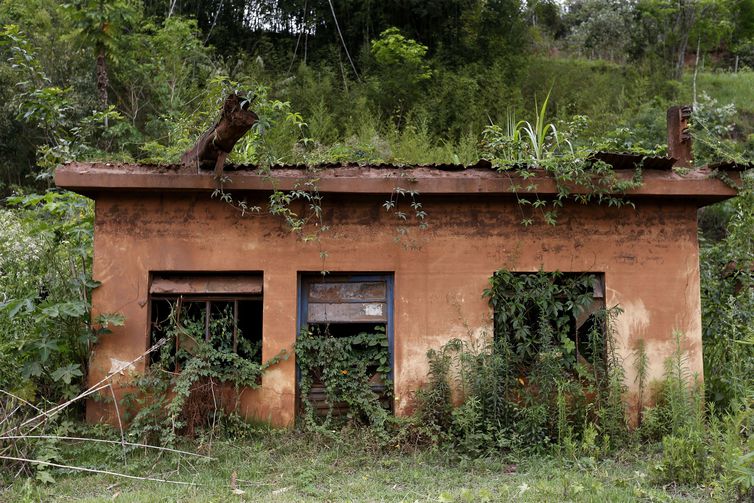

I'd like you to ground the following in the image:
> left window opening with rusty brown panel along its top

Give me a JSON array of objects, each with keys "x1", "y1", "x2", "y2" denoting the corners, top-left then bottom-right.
[{"x1": 150, "y1": 273, "x2": 262, "y2": 371}]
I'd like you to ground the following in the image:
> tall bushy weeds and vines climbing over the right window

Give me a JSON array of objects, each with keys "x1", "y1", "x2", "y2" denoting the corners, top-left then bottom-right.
[{"x1": 417, "y1": 270, "x2": 627, "y2": 456}]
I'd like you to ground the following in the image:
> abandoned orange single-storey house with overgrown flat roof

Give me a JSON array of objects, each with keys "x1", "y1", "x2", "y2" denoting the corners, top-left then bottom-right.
[{"x1": 55, "y1": 108, "x2": 740, "y2": 426}]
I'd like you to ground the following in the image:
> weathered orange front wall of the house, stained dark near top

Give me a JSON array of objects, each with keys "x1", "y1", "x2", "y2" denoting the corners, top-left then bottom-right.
[{"x1": 87, "y1": 192, "x2": 702, "y2": 425}]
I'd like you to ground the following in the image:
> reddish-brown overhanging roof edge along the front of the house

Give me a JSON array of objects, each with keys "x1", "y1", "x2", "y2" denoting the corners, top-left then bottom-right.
[{"x1": 55, "y1": 158, "x2": 742, "y2": 205}]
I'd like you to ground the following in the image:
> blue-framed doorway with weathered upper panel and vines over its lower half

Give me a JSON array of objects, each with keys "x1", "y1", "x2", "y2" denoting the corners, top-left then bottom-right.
[{"x1": 299, "y1": 274, "x2": 393, "y2": 416}]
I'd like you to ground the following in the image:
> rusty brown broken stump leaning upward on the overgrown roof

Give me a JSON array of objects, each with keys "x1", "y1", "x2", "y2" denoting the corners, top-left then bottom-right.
[{"x1": 181, "y1": 93, "x2": 259, "y2": 177}]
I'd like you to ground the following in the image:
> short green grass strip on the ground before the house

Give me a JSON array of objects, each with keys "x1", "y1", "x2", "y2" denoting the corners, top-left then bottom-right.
[{"x1": 0, "y1": 430, "x2": 711, "y2": 503}]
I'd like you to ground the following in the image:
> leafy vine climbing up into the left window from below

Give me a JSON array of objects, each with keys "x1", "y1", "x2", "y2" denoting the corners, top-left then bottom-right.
[{"x1": 125, "y1": 301, "x2": 287, "y2": 445}]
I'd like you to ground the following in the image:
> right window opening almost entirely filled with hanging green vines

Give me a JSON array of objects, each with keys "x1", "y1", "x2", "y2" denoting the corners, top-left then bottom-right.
[{"x1": 486, "y1": 270, "x2": 605, "y2": 375}]
